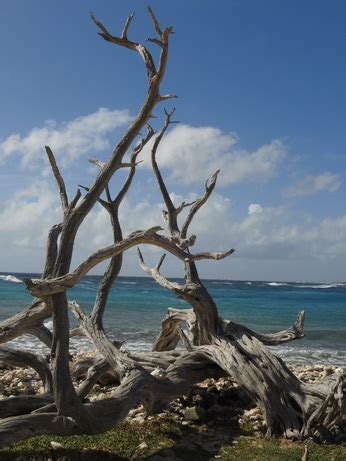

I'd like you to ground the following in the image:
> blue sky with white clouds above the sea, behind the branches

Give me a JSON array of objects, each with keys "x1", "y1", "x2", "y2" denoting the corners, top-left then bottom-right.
[{"x1": 0, "y1": 0, "x2": 346, "y2": 282}]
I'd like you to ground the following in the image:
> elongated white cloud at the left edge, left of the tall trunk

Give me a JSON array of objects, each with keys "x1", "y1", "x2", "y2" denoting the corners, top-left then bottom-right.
[{"x1": 0, "y1": 107, "x2": 130, "y2": 167}]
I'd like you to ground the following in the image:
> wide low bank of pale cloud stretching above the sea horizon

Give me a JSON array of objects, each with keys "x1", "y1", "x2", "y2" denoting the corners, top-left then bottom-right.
[{"x1": 0, "y1": 182, "x2": 346, "y2": 279}]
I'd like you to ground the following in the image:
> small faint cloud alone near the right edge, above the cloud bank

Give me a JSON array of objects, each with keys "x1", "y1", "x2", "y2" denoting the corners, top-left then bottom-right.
[{"x1": 284, "y1": 171, "x2": 341, "y2": 197}]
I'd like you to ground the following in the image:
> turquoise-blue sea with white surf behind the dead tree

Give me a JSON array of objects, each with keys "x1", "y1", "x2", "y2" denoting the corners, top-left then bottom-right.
[{"x1": 0, "y1": 273, "x2": 346, "y2": 366}]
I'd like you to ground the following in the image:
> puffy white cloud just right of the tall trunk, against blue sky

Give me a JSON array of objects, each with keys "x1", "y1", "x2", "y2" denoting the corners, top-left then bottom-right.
[{"x1": 142, "y1": 125, "x2": 286, "y2": 185}]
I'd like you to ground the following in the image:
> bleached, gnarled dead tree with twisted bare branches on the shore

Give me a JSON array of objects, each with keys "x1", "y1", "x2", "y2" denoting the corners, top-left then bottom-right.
[{"x1": 0, "y1": 8, "x2": 345, "y2": 445}]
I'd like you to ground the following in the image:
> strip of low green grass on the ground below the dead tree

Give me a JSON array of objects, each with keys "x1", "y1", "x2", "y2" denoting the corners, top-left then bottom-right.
[{"x1": 0, "y1": 417, "x2": 346, "y2": 461}]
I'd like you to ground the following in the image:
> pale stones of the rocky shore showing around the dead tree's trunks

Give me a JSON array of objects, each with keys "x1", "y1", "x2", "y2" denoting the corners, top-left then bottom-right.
[{"x1": 0, "y1": 353, "x2": 337, "y2": 431}]
